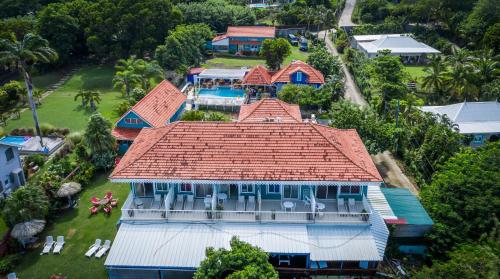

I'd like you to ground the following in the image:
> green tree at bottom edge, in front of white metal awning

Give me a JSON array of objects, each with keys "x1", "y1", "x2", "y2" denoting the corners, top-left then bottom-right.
[{"x1": 194, "y1": 237, "x2": 278, "y2": 279}]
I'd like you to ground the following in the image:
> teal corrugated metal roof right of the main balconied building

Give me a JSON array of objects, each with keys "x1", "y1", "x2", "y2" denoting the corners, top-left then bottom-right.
[{"x1": 381, "y1": 188, "x2": 434, "y2": 225}]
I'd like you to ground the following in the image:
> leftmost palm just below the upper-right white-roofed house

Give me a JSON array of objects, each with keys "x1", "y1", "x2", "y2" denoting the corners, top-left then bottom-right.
[{"x1": 422, "y1": 56, "x2": 447, "y2": 103}]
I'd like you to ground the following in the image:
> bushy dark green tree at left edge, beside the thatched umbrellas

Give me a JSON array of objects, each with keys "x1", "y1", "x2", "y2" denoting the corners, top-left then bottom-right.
[{"x1": 2, "y1": 185, "x2": 49, "y2": 226}]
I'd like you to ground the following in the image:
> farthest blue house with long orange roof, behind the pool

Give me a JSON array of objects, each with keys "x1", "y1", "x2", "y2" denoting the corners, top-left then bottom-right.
[{"x1": 208, "y1": 26, "x2": 276, "y2": 55}]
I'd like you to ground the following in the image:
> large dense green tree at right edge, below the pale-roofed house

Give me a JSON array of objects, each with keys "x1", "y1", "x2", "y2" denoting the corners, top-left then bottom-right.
[{"x1": 421, "y1": 142, "x2": 500, "y2": 255}]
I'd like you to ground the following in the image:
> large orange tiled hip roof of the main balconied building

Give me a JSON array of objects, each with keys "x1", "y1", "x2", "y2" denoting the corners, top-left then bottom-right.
[{"x1": 110, "y1": 121, "x2": 382, "y2": 182}]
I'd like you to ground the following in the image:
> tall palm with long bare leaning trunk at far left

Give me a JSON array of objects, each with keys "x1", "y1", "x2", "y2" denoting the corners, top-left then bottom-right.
[{"x1": 0, "y1": 33, "x2": 58, "y2": 146}]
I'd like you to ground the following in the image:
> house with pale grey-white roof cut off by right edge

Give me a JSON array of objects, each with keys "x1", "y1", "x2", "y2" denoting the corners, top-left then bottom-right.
[{"x1": 420, "y1": 101, "x2": 500, "y2": 147}]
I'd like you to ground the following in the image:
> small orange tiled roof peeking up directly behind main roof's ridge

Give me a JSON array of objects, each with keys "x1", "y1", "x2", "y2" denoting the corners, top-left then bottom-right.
[{"x1": 238, "y1": 99, "x2": 302, "y2": 123}]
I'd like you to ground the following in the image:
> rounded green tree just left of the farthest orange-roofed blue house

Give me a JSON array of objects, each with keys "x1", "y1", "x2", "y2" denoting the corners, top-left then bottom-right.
[{"x1": 155, "y1": 24, "x2": 213, "y2": 70}]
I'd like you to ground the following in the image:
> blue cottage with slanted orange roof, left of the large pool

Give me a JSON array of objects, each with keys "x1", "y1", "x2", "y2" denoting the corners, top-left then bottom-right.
[{"x1": 112, "y1": 80, "x2": 186, "y2": 153}]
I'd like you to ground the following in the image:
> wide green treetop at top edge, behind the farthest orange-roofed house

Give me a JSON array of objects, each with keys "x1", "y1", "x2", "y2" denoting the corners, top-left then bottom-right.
[{"x1": 177, "y1": 0, "x2": 256, "y2": 33}]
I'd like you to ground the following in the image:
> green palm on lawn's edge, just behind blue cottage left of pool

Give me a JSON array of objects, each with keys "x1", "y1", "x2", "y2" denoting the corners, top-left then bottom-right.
[{"x1": 113, "y1": 56, "x2": 141, "y2": 97}]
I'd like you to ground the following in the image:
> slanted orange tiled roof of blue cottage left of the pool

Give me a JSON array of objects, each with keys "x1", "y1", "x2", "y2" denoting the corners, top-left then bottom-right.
[{"x1": 127, "y1": 80, "x2": 186, "y2": 127}]
